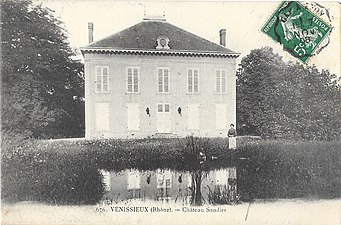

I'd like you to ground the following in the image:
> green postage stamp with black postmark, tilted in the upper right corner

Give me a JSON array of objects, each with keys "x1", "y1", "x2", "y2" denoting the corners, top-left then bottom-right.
[{"x1": 262, "y1": 1, "x2": 332, "y2": 63}]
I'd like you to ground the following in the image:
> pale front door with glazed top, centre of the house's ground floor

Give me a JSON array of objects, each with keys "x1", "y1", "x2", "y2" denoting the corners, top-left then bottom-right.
[{"x1": 157, "y1": 103, "x2": 172, "y2": 133}]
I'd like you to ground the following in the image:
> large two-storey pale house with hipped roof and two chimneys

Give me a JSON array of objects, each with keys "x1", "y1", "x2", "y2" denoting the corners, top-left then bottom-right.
[{"x1": 81, "y1": 17, "x2": 240, "y2": 138}]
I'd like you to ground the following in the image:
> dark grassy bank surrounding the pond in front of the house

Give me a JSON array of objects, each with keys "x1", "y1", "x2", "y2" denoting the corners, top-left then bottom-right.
[{"x1": 2, "y1": 138, "x2": 341, "y2": 204}]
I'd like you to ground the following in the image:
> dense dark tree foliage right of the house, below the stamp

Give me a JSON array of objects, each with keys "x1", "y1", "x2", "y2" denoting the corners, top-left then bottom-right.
[{"x1": 237, "y1": 47, "x2": 341, "y2": 140}]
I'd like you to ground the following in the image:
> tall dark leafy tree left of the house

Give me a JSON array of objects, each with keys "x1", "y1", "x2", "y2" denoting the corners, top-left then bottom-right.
[{"x1": 1, "y1": 0, "x2": 84, "y2": 138}]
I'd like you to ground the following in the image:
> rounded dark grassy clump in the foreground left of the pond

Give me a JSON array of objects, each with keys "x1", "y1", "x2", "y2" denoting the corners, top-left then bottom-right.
[{"x1": 1, "y1": 141, "x2": 104, "y2": 204}]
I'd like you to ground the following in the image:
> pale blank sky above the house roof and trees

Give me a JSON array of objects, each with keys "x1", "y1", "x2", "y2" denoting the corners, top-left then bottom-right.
[{"x1": 34, "y1": 0, "x2": 341, "y2": 75}]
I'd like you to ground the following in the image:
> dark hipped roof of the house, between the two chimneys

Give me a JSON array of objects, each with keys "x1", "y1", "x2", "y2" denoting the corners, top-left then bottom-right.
[{"x1": 82, "y1": 20, "x2": 239, "y2": 57}]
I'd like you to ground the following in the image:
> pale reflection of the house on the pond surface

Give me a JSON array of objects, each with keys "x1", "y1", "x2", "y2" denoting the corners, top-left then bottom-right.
[{"x1": 101, "y1": 167, "x2": 237, "y2": 204}]
